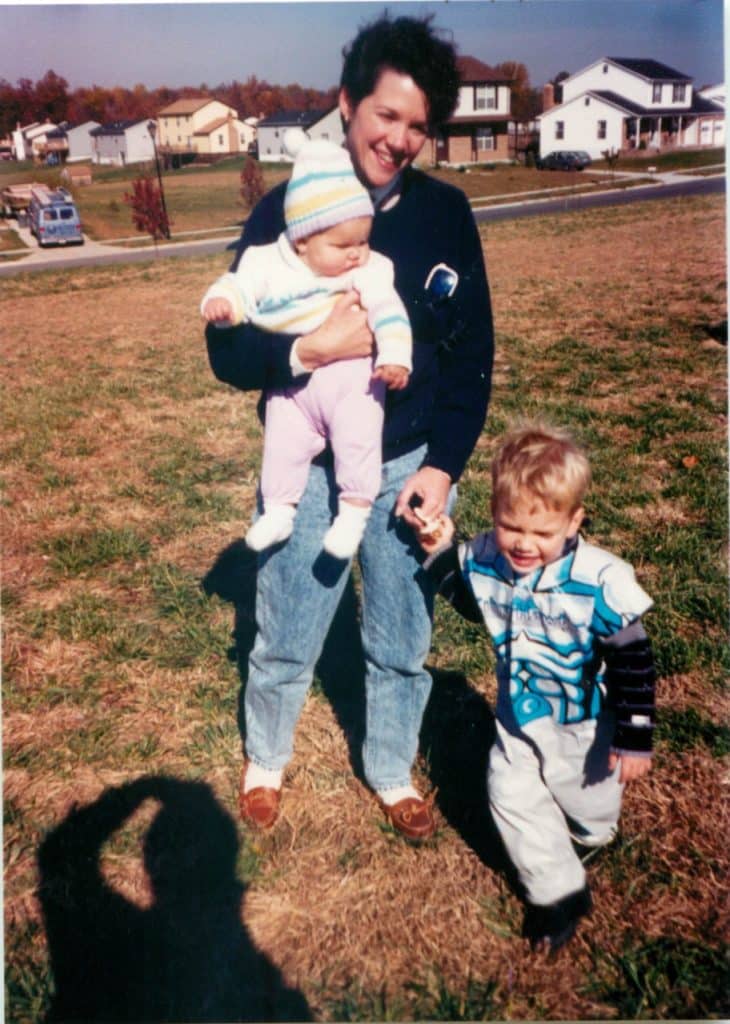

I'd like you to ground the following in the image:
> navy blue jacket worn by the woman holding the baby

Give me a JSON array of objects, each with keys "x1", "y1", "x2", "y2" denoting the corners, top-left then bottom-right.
[{"x1": 206, "y1": 168, "x2": 493, "y2": 480}]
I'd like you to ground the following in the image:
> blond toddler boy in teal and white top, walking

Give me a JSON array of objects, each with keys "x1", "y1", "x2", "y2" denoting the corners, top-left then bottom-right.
[{"x1": 419, "y1": 424, "x2": 654, "y2": 950}]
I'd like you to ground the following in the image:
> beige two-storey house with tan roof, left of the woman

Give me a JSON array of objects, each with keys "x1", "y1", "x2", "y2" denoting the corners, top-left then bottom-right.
[{"x1": 158, "y1": 96, "x2": 256, "y2": 154}]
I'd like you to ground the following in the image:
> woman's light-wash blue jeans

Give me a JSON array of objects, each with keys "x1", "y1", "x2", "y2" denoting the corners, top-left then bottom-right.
[{"x1": 245, "y1": 447, "x2": 433, "y2": 791}]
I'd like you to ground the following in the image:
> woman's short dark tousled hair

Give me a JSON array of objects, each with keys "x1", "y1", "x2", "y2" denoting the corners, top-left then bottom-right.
[{"x1": 340, "y1": 11, "x2": 460, "y2": 129}]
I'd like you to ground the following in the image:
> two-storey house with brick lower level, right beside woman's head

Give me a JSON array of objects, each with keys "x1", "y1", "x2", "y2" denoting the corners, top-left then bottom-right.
[{"x1": 423, "y1": 56, "x2": 514, "y2": 164}]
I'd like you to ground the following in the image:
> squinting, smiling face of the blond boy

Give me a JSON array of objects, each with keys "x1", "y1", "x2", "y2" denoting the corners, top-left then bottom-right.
[{"x1": 493, "y1": 495, "x2": 584, "y2": 573}]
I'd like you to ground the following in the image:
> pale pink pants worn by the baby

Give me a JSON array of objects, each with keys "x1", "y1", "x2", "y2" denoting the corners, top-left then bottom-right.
[{"x1": 261, "y1": 356, "x2": 385, "y2": 507}]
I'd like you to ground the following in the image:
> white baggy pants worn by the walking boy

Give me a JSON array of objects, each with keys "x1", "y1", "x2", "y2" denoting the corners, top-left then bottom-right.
[{"x1": 487, "y1": 713, "x2": 624, "y2": 906}]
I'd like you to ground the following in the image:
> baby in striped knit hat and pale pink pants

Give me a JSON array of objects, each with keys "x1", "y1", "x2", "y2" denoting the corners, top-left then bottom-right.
[{"x1": 201, "y1": 140, "x2": 412, "y2": 559}]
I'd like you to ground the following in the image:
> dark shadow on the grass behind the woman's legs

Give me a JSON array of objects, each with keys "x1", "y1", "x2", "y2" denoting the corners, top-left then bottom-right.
[{"x1": 203, "y1": 541, "x2": 515, "y2": 885}]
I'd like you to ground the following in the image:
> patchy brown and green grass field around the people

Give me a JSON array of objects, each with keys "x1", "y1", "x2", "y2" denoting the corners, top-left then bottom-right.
[{"x1": 0, "y1": 188, "x2": 730, "y2": 1024}]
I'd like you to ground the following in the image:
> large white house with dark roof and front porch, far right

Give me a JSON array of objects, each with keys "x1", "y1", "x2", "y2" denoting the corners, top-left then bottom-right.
[{"x1": 539, "y1": 57, "x2": 725, "y2": 160}]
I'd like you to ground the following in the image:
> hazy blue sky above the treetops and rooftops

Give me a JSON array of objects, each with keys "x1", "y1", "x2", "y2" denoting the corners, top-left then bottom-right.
[{"x1": 0, "y1": 0, "x2": 725, "y2": 88}]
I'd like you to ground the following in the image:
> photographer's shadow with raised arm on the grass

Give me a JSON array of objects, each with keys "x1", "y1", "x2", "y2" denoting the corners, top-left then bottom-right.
[{"x1": 39, "y1": 776, "x2": 310, "y2": 1021}]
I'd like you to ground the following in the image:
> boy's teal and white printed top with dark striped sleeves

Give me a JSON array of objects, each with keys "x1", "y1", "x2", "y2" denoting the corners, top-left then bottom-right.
[{"x1": 426, "y1": 532, "x2": 654, "y2": 753}]
